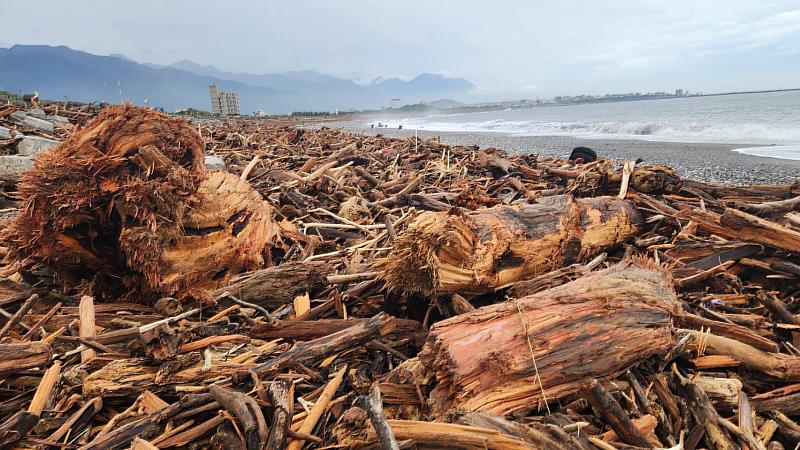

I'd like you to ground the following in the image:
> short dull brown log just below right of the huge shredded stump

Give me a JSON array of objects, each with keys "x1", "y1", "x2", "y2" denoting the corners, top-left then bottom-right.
[{"x1": 216, "y1": 261, "x2": 333, "y2": 309}]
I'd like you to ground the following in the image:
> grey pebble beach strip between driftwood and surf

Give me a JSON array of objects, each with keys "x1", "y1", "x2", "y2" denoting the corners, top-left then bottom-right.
[{"x1": 327, "y1": 122, "x2": 800, "y2": 184}]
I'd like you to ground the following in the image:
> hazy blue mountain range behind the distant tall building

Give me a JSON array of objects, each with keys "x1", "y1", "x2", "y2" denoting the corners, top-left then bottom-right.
[{"x1": 0, "y1": 45, "x2": 475, "y2": 114}]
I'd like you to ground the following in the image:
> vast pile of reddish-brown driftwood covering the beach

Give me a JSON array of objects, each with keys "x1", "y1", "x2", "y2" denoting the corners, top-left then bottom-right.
[{"x1": 0, "y1": 105, "x2": 800, "y2": 450}]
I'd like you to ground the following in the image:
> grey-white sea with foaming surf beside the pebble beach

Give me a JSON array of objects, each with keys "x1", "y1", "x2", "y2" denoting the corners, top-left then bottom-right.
[{"x1": 366, "y1": 91, "x2": 800, "y2": 160}]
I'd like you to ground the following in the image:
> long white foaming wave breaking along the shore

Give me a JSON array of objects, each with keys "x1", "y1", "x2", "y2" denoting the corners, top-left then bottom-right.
[{"x1": 388, "y1": 118, "x2": 800, "y2": 144}]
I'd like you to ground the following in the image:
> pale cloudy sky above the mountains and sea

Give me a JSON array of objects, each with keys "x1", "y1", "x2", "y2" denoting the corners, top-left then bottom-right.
[{"x1": 0, "y1": 0, "x2": 800, "y2": 98}]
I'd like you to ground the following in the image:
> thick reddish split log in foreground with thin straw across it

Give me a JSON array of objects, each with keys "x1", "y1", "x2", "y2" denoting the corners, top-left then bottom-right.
[{"x1": 420, "y1": 261, "x2": 678, "y2": 415}]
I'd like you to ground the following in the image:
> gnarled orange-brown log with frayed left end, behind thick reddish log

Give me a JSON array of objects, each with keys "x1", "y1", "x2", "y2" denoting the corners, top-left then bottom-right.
[{"x1": 377, "y1": 196, "x2": 641, "y2": 296}]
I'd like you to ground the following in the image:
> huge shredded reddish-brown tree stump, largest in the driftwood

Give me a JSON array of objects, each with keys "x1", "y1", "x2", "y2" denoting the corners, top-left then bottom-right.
[{"x1": 6, "y1": 105, "x2": 275, "y2": 296}]
